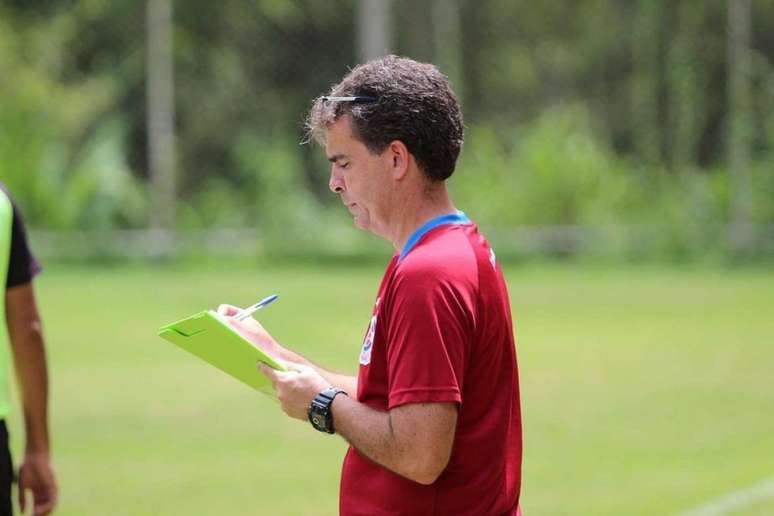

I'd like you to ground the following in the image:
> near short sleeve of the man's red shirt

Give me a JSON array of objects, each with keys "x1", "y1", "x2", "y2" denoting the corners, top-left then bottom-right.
[{"x1": 385, "y1": 271, "x2": 474, "y2": 408}]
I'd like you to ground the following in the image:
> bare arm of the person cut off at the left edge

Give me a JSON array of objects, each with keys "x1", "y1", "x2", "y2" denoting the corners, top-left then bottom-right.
[{"x1": 5, "y1": 283, "x2": 57, "y2": 515}]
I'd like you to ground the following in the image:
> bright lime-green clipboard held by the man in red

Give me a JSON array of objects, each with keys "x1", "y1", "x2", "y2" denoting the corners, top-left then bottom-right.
[{"x1": 158, "y1": 310, "x2": 288, "y2": 396}]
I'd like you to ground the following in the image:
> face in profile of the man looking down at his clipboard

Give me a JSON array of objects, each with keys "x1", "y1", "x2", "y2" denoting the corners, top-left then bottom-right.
[{"x1": 325, "y1": 116, "x2": 391, "y2": 236}]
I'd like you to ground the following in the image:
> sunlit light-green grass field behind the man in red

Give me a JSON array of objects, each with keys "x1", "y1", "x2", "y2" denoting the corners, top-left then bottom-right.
[{"x1": 11, "y1": 265, "x2": 774, "y2": 516}]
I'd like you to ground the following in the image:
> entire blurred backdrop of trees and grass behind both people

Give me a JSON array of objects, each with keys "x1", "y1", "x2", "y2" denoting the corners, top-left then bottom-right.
[{"x1": 0, "y1": 0, "x2": 774, "y2": 515}]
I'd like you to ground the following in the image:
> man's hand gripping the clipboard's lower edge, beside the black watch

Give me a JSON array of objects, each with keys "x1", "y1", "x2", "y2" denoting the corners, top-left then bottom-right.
[{"x1": 258, "y1": 362, "x2": 330, "y2": 421}]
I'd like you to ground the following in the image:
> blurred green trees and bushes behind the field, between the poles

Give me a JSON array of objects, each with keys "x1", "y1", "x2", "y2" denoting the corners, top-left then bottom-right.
[{"x1": 0, "y1": 0, "x2": 774, "y2": 260}]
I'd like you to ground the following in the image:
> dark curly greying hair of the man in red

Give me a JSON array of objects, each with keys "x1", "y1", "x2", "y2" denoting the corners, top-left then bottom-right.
[{"x1": 306, "y1": 55, "x2": 463, "y2": 181}]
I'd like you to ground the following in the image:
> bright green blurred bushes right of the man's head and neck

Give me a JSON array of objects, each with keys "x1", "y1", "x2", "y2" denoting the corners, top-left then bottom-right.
[{"x1": 451, "y1": 106, "x2": 756, "y2": 259}]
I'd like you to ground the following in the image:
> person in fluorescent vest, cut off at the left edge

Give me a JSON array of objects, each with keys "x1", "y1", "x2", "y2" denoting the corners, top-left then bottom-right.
[{"x1": 0, "y1": 183, "x2": 57, "y2": 516}]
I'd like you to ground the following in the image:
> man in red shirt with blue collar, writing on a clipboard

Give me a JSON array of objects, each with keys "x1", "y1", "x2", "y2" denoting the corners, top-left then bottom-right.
[{"x1": 221, "y1": 56, "x2": 521, "y2": 516}]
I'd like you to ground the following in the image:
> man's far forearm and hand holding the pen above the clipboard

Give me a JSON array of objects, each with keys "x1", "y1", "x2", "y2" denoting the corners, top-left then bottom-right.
[{"x1": 218, "y1": 305, "x2": 357, "y2": 396}]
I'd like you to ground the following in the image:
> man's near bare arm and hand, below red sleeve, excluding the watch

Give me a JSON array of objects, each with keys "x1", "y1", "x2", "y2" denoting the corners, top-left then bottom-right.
[{"x1": 259, "y1": 364, "x2": 457, "y2": 485}]
